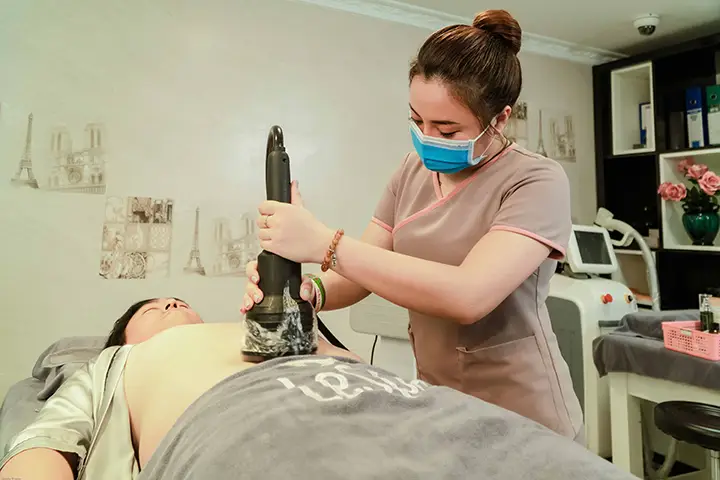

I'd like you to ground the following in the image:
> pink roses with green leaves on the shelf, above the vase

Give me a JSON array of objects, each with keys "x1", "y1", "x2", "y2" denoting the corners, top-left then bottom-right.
[{"x1": 658, "y1": 158, "x2": 720, "y2": 213}]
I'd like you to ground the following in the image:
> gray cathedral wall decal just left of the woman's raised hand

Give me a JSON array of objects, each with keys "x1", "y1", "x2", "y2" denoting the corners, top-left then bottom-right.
[{"x1": 207, "y1": 213, "x2": 261, "y2": 277}]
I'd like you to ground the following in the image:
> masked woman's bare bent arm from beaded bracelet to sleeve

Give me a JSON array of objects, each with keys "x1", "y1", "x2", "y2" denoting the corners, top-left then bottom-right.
[{"x1": 334, "y1": 231, "x2": 550, "y2": 324}]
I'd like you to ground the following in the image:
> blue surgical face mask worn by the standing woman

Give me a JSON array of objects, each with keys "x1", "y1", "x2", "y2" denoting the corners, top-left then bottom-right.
[{"x1": 410, "y1": 118, "x2": 495, "y2": 174}]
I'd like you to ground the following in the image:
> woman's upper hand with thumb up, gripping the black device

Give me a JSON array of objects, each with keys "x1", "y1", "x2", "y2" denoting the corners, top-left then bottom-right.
[{"x1": 257, "y1": 182, "x2": 335, "y2": 263}]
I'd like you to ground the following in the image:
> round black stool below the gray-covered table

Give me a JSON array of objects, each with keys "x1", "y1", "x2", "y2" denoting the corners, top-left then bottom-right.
[{"x1": 655, "y1": 402, "x2": 720, "y2": 480}]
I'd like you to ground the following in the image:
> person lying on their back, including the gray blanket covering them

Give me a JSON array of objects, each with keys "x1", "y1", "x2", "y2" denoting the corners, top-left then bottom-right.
[{"x1": 0, "y1": 298, "x2": 634, "y2": 480}]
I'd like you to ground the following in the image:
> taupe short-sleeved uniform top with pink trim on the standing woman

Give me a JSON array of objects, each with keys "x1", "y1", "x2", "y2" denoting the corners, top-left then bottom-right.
[{"x1": 373, "y1": 144, "x2": 583, "y2": 438}]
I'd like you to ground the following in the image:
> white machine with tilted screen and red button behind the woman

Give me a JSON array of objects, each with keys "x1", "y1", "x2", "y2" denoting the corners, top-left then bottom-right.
[{"x1": 547, "y1": 225, "x2": 638, "y2": 457}]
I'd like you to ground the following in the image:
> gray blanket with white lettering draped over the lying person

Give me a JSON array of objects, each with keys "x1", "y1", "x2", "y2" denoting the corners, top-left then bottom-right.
[{"x1": 138, "y1": 357, "x2": 634, "y2": 480}]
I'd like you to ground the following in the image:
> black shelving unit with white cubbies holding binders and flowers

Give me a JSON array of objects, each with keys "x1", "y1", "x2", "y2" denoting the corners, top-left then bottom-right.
[{"x1": 593, "y1": 34, "x2": 720, "y2": 309}]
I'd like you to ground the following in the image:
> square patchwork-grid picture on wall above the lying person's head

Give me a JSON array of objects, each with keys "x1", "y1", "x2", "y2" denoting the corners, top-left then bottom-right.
[{"x1": 100, "y1": 197, "x2": 173, "y2": 280}]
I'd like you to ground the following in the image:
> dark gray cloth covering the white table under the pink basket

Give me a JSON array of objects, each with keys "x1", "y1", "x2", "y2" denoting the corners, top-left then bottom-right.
[{"x1": 593, "y1": 310, "x2": 720, "y2": 389}]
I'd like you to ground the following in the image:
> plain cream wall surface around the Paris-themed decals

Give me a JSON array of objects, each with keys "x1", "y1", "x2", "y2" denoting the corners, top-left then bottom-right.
[{"x1": 0, "y1": 0, "x2": 594, "y2": 396}]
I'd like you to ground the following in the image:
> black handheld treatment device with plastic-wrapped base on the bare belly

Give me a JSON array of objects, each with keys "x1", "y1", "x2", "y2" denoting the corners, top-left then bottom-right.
[{"x1": 243, "y1": 126, "x2": 317, "y2": 359}]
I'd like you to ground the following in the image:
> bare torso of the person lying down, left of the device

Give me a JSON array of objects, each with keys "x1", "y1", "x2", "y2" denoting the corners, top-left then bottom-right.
[{"x1": 125, "y1": 323, "x2": 252, "y2": 468}]
